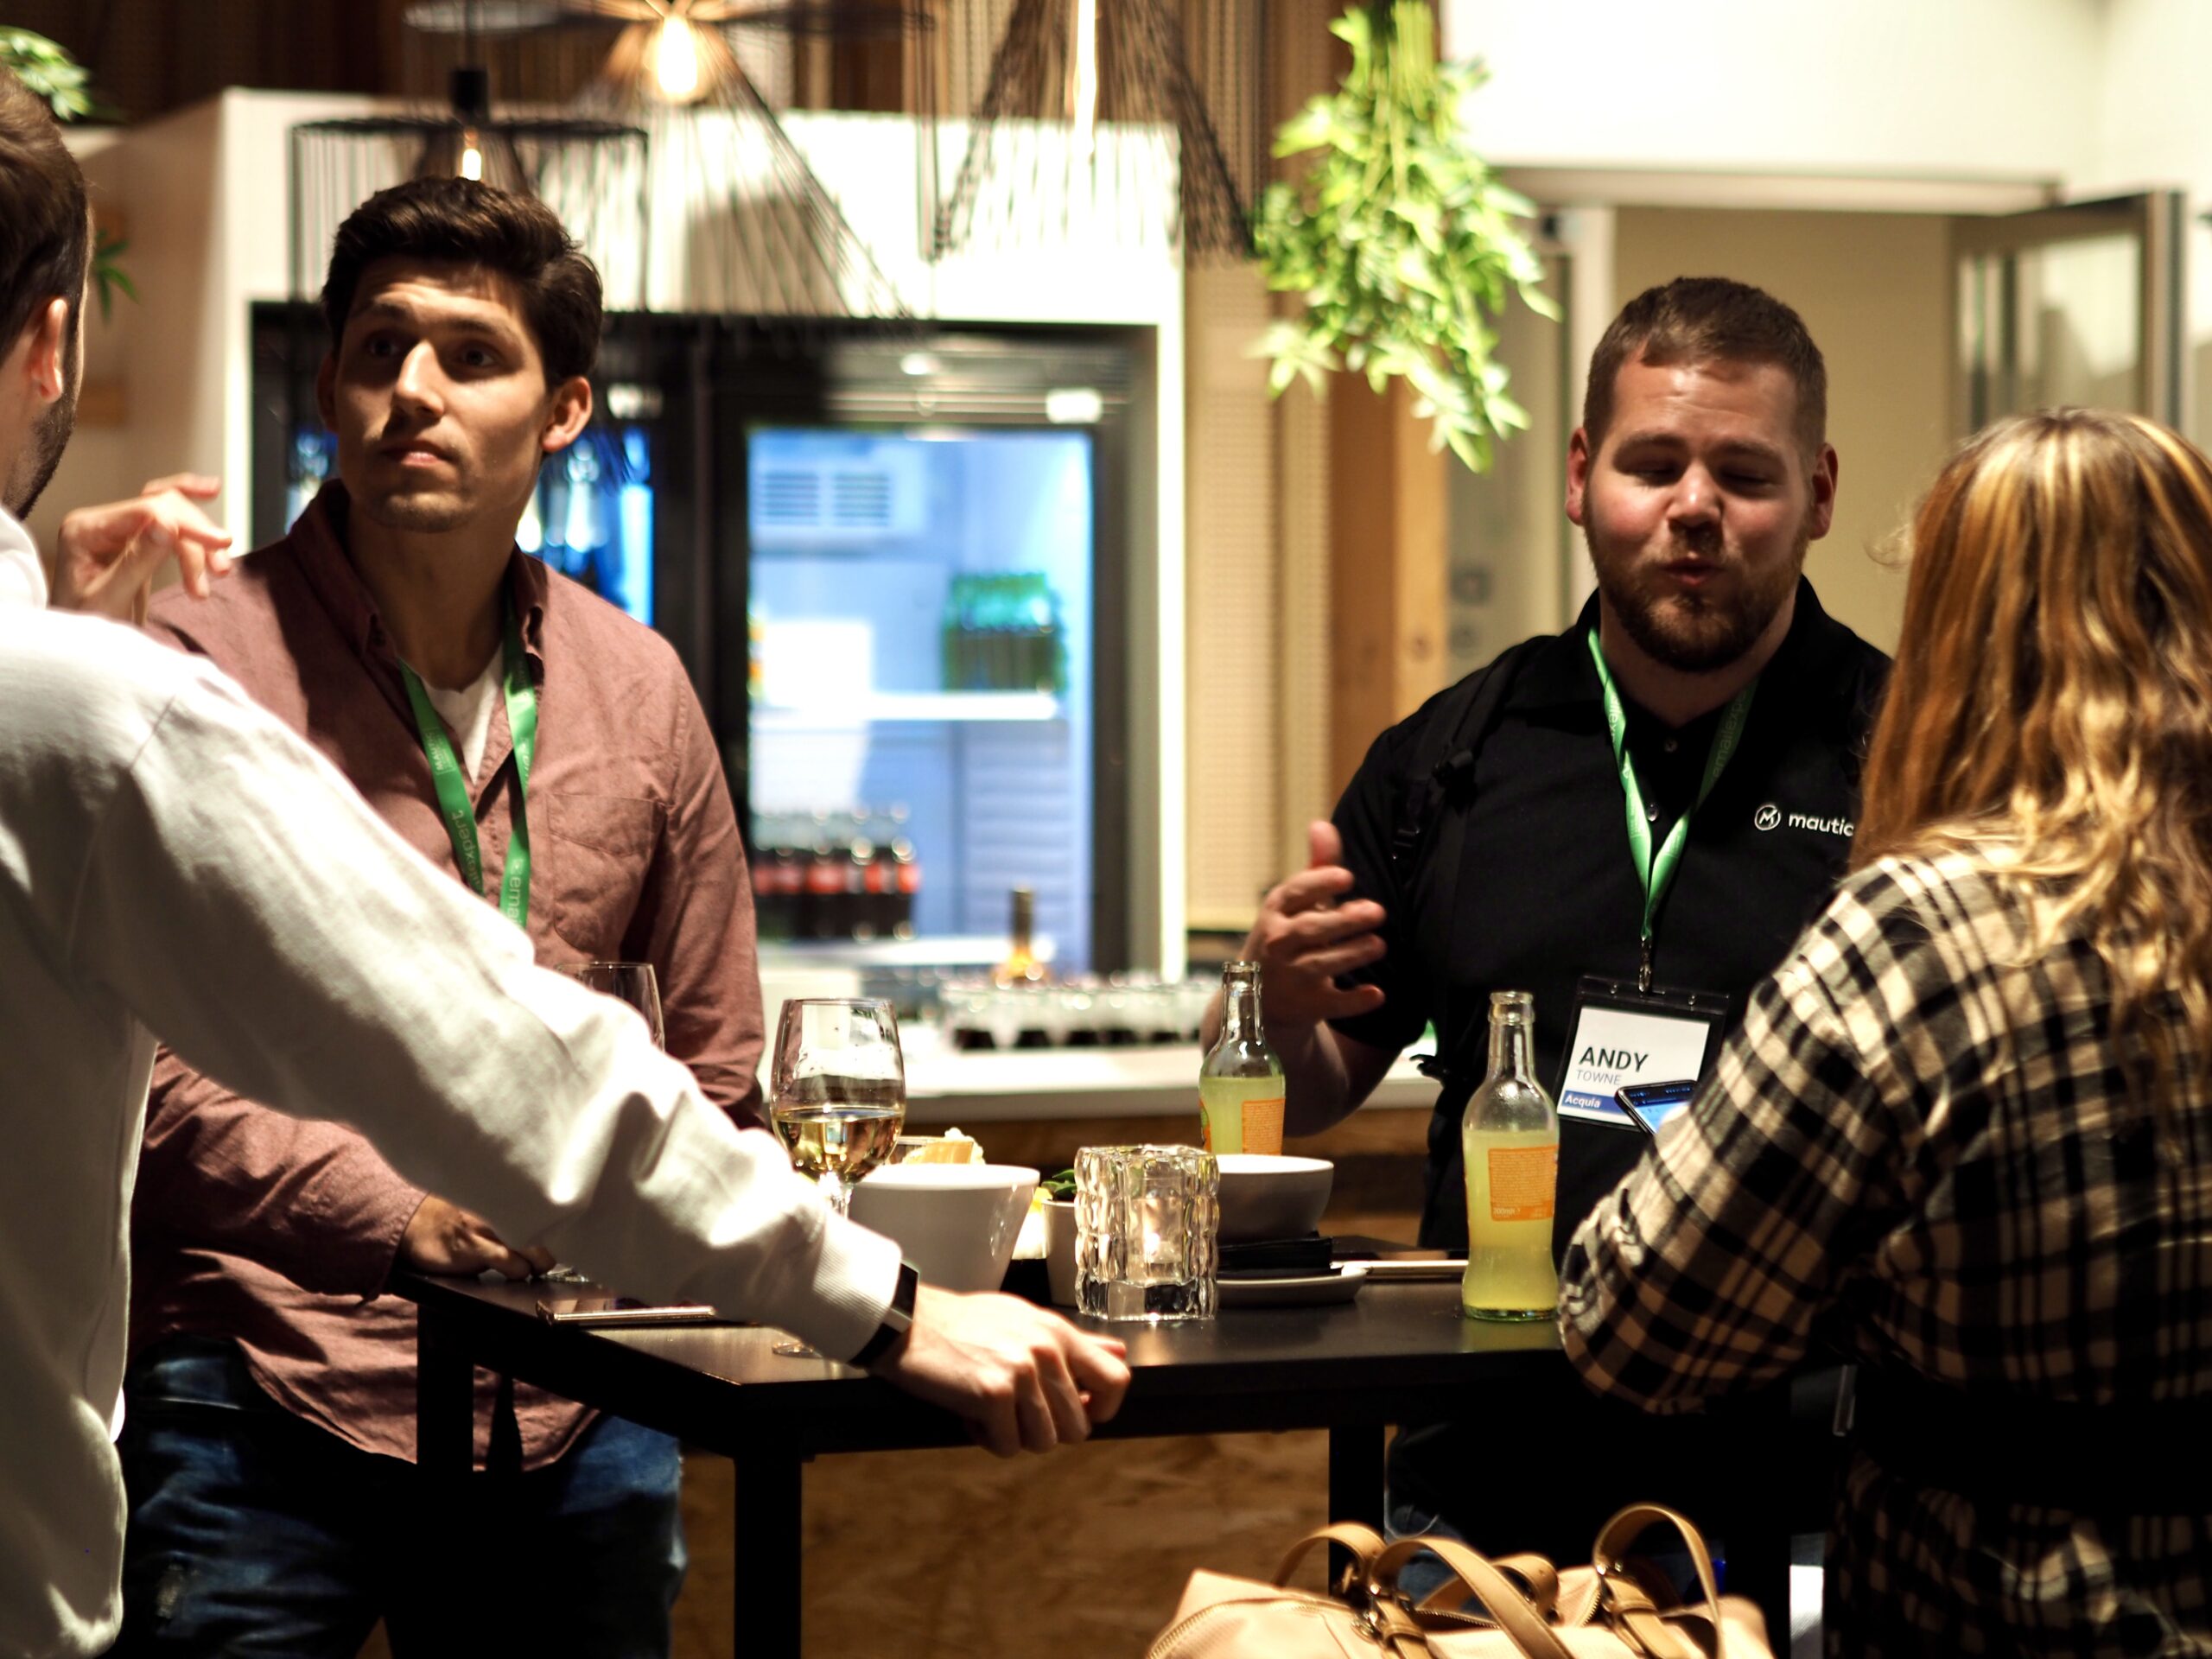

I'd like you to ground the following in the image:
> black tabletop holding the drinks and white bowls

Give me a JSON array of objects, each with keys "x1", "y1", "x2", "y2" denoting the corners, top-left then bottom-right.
[{"x1": 394, "y1": 1274, "x2": 1580, "y2": 1451}]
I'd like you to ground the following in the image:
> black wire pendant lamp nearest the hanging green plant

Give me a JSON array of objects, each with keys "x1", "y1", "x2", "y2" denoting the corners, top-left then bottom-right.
[{"x1": 938, "y1": 0, "x2": 1261, "y2": 259}]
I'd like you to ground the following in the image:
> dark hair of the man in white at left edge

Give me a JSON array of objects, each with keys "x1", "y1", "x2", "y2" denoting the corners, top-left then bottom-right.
[{"x1": 0, "y1": 68, "x2": 93, "y2": 354}]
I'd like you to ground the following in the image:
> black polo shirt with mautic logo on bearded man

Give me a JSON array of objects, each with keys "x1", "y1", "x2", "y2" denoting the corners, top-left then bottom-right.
[{"x1": 1336, "y1": 580, "x2": 1889, "y2": 1248}]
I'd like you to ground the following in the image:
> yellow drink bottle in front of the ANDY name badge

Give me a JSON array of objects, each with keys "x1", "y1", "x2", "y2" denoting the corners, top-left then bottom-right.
[{"x1": 1460, "y1": 991, "x2": 1560, "y2": 1320}]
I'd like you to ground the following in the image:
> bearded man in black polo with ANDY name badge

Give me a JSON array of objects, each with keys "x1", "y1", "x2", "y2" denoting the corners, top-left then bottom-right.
[{"x1": 1208, "y1": 276, "x2": 1887, "y2": 1583}]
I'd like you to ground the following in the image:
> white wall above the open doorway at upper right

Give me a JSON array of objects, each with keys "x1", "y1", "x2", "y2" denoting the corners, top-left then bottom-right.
[{"x1": 1438, "y1": 0, "x2": 2096, "y2": 177}]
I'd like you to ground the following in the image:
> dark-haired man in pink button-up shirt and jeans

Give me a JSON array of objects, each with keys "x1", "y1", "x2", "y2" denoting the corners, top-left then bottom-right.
[{"x1": 122, "y1": 179, "x2": 761, "y2": 1655}]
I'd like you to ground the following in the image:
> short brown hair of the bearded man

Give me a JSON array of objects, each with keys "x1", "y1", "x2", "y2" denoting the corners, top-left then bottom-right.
[{"x1": 1581, "y1": 276, "x2": 1827, "y2": 455}]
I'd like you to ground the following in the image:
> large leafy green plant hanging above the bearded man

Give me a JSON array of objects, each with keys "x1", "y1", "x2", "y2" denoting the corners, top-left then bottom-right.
[{"x1": 1255, "y1": 0, "x2": 1560, "y2": 471}]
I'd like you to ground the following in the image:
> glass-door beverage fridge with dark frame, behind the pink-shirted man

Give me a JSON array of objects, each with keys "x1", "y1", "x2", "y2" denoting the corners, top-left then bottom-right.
[{"x1": 254, "y1": 308, "x2": 1150, "y2": 971}]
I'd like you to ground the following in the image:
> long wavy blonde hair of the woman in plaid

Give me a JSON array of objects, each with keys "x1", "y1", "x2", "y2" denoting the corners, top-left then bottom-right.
[{"x1": 1852, "y1": 410, "x2": 2212, "y2": 1128}]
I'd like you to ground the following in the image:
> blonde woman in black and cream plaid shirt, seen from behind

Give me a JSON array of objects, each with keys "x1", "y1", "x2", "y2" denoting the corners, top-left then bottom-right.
[{"x1": 1560, "y1": 410, "x2": 2212, "y2": 1659}]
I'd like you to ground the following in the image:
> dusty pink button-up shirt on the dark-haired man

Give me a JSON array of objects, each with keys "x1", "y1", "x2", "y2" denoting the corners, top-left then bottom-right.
[{"x1": 130, "y1": 485, "x2": 761, "y2": 1466}]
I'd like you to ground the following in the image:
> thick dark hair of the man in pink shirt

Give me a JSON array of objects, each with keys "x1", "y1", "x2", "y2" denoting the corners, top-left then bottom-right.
[{"x1": 323, "y1": 179, "x2": 600, "y2": 385}]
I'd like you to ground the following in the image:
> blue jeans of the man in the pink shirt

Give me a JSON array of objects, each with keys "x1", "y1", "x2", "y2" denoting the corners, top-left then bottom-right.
[{"x1": 115, "y1": 1338, "x2": 686, "y2": 1659}]
